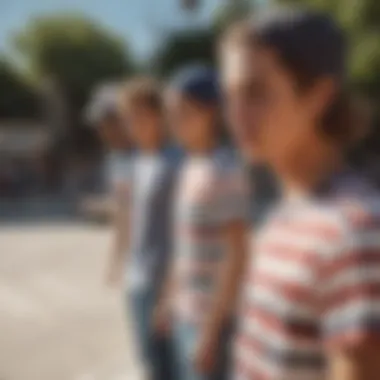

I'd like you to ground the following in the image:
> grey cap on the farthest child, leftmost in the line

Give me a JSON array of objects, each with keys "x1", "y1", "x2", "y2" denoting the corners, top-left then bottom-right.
[{"x1": 85, "y1": 84, "x2": 119, "y2": 126}]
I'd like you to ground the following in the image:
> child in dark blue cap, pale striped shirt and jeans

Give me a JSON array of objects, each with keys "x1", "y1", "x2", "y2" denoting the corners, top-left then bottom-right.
[{"x1": 155, "y1": 66, "x2": 249, "y2": 380}]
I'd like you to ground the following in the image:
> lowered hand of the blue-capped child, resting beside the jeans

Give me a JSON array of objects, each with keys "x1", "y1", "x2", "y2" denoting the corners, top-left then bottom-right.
[{"x1": 194, "y1": 333, "x2": 218, "y2": 374}]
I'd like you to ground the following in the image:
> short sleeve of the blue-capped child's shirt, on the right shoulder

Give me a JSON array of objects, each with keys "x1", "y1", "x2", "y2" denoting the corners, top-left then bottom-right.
[{"x1": 216, "y1": 167, "x2": 250, "y2": 224}]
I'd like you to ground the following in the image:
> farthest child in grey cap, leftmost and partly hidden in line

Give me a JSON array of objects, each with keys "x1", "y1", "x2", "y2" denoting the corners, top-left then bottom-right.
[{"x1": 86, "y1": 84, "x2": 131, "y2": 285}]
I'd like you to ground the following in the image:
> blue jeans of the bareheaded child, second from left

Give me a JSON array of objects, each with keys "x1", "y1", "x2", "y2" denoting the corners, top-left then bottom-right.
[{"x1": 128, "y1": 289, "x2": 177, "y2": 380}]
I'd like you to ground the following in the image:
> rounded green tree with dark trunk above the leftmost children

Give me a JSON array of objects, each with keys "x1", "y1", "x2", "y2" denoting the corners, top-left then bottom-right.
[{"x1": 15, "y1": 14, "x2": 133, "y2": 153}]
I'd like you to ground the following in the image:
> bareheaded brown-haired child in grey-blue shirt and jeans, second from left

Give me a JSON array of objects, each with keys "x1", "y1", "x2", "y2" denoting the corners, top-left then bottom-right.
[{"x1": 121, "y1": 78, "x2": 179, "y2": 380}]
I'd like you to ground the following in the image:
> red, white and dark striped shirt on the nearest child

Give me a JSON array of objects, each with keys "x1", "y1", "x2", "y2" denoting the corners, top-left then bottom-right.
[{"x1": 232, "y1": 176, "x2": 380, "y2": 380}]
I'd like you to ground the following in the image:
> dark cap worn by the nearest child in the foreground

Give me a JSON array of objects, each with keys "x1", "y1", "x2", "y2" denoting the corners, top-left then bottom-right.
[{"x1": 249, "y1": 7, "x2": 347, "y2": 81}]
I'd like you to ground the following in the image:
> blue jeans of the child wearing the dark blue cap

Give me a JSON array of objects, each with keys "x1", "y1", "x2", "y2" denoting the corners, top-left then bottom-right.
[{"x1": 174, "y1": 321, "x2": 233, "y2": 380}]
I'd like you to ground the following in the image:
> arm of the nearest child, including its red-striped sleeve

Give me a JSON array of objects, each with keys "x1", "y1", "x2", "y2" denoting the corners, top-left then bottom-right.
[{"x1": 318, "y1": 212, "x2": 380, "y2": 380}]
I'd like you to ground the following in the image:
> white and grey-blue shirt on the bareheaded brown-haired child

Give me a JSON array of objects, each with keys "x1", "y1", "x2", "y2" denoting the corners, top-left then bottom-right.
[{"x1": 127, "y1": 148, "x2": 180, "y2": 291}]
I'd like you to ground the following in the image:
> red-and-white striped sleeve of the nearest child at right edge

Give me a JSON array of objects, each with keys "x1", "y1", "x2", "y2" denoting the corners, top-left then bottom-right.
[{"x1": 320, "y1": 208, "x2": 380, "y2": 349}]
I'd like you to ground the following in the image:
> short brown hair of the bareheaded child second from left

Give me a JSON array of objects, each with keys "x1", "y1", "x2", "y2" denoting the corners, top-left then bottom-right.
[{"x1": 120, "y1": 77, "x2": 163, "y2": 112}]
